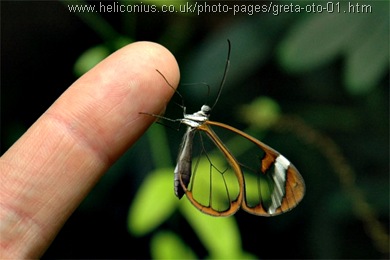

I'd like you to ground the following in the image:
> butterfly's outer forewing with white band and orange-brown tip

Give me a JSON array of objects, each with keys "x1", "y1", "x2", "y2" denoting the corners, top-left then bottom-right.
[{"x1": 202, "y1": 121, "x2": 305, "y2": 216}]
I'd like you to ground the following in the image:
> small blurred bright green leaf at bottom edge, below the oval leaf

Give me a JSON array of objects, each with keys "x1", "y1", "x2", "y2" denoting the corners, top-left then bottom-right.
[{"x1": 150, "y1": 232, "x2": 198, "y2": 259}]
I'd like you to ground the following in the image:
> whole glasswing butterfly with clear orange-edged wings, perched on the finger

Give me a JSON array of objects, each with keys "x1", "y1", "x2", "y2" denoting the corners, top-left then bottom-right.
[{"x1": 142, "y1": 40, "x2": 305, "y2": 217}]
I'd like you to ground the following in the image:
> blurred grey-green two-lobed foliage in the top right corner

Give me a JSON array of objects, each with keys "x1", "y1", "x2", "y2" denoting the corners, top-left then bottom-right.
[{"x1": 278, "y1": 1, "x2": 389, "y2": 95}]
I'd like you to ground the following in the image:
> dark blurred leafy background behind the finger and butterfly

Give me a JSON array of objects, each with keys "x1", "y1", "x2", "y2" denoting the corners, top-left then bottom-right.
[{"x1": 1, "y1": 0, "x2": 389, "y2": 259}]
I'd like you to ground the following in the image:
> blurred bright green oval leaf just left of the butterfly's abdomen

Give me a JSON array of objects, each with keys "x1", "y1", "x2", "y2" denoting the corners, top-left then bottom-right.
[{"x1": 128, "y1": 168, "x2": 178, "y2": 235}]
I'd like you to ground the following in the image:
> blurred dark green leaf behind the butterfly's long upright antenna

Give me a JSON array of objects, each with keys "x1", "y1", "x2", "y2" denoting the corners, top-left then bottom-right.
[{"x1": 182, "y1": 17, "x2": 277, "y2": 97}]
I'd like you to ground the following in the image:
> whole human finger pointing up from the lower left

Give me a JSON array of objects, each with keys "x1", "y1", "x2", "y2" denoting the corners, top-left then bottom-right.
[{"x1": 0, "y1": 42, "x2": 180, "y2": 259}]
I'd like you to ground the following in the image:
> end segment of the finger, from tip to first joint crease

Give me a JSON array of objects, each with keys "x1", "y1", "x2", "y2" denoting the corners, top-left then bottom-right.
[{"x1": 58, "y1": 41, "x2": 180, "y2": 158}]
